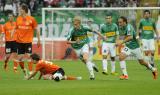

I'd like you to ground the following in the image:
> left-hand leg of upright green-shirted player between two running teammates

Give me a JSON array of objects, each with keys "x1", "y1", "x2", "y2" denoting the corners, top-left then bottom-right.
[{"x1": 102, "y1": 42, "x2": 109, "y2": 75}]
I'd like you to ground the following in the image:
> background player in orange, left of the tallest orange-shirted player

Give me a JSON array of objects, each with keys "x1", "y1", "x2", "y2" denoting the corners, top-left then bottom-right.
[{"x1": 2, "y1": 12, "x2": 18, "y2": 72}]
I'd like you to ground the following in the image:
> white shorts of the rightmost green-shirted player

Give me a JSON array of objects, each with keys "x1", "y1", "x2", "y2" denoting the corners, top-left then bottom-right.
[{"x1": 142, "y1": 39, "x2": 155, "y2": 51}]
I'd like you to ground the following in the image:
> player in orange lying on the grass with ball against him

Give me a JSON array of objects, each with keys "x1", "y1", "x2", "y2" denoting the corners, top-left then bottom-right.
[{"x1": 27, "y1": 54, "x2": 81, "y2": 81}]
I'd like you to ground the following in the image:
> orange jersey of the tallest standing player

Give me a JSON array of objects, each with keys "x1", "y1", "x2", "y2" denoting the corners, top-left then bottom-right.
[{"x1": 16, "y1": 16, "x2": 37, "y2": 43}]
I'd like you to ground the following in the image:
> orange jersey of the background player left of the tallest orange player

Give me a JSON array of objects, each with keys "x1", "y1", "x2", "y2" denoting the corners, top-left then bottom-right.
[{"x1": 2, "y1": 21, "x2": 17, "y2": 41}]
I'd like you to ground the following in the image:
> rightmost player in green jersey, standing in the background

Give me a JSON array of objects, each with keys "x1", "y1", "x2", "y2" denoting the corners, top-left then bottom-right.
[{"x1": 137, "y1": 10, "x2": 159, "y2": 66}]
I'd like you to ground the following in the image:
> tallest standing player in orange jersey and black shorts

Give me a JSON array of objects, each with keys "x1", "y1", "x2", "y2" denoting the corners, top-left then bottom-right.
[{"x1": 16, "y1": 4, "x2": 40, "y2": 77}]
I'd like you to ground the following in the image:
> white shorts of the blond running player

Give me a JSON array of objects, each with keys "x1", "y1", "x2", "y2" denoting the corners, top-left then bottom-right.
[{"x1": 75, "y1": 44, "x2": 89, "y2": 57}]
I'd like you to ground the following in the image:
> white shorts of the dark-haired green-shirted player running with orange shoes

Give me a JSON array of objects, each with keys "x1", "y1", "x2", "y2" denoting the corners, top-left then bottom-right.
[{"x1": 121, "y1": 47, "x2": 143, "y2": 59}]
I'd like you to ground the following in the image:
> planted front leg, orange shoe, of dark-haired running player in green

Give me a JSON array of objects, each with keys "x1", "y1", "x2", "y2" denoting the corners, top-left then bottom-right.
[{"x1": 119, "y1": 47, "x2": 130, "y2": 79}]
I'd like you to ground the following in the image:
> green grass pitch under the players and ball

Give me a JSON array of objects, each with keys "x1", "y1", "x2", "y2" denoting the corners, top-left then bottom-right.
[{"x1": 0, "y1": 61, "x2": 160, "y2": 95}]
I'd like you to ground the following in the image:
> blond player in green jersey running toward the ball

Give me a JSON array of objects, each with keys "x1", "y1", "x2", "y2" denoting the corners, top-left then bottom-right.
[{"x1": 67, "y1": 16, "x2": 103, "y2": 80}]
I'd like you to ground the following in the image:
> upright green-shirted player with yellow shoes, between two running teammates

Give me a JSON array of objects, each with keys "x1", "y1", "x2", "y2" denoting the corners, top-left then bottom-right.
[{"x1": 98, "y1": 14, "x2": 119, "y2": 75}]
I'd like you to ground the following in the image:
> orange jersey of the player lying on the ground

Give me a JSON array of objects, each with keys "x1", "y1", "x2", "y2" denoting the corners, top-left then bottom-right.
[{"x1": 35, "y1": 60, "x2": 60, "y2": 74}]
